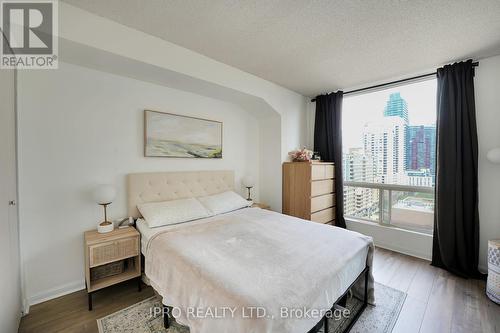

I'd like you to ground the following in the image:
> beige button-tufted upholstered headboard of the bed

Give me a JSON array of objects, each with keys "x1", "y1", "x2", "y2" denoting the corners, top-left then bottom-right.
[{"x1": 127, "y1": 171, "x2": 234, "y2": 217}]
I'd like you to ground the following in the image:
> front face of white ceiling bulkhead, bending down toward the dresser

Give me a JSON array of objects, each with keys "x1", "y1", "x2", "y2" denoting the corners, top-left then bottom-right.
[{"x1": 59, "y1": 2, "x2": 307, "y2": 160}]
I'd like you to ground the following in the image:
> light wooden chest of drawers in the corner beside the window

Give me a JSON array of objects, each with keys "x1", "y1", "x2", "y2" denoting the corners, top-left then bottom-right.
[{"x1": 283, "y1": 162, "x2": 335, "y2": 225}]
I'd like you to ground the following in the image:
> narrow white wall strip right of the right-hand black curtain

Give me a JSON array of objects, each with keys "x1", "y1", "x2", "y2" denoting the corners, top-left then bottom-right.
[{"x1": 474, "y1": 56, "x2": 500, "y2": 272}]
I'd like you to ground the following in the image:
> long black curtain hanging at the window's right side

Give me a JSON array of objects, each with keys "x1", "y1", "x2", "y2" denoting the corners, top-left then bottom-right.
[{"x1": 432, "y1": 60, "x2": 480, "y2": 277}]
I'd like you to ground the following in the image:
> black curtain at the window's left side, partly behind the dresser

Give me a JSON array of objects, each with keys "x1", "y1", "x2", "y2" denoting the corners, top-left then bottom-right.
[{"x1": 314, "y1": 91, "x2": 345, "y2": 228}]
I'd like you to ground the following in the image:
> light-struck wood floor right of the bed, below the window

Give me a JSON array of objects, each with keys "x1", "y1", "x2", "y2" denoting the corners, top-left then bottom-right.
[{"x1": 373, "y1": 248, "x2": 500, "y2": 333}]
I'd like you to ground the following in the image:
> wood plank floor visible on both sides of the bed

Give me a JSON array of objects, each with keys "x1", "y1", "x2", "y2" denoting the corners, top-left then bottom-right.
[{"x1": 19, "y1": 248, "x2": 500, "y2": 333}]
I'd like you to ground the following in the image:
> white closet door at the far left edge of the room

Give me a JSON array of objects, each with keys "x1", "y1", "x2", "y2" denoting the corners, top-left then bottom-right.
[{"x1": 0, "y1": 69, "x2": 21, "y2": 332}]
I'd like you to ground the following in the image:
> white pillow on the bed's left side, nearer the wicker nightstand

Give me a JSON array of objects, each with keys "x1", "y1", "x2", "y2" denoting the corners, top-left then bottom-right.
[{"x1": 137, "y1": 198, "x2": 210, "y2": 228}]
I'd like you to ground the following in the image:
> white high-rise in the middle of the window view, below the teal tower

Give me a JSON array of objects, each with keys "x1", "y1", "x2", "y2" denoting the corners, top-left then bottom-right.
[{"x1": 363, "y1": 116, "x2": 407, "y2": 183}]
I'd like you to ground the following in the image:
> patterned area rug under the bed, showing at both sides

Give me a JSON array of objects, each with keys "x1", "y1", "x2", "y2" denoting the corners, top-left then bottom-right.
[{"x1": 97, "y1": 283, "x2": 406, "y2": 333}]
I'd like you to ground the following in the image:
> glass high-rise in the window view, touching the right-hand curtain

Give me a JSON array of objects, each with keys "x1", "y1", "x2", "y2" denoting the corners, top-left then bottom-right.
[{"x1": 406, "y1": 125, "x2": 436, "y2": 175}]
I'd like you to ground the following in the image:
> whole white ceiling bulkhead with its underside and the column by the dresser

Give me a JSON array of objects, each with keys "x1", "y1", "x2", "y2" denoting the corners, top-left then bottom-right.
[{"x1": 55, "y1": 2, "x2": 307, "y2": 211}]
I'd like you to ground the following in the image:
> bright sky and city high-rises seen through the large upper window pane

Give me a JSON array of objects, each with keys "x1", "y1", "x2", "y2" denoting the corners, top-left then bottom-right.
[{"x1": 343, "y1": 80, "x2": 436, "y2": 186}]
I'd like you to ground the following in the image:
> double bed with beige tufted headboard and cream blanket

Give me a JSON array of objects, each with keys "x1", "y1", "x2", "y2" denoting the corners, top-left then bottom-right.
[{"x1": 128, "y1": 171, "x2": 374, "y2": 333}]
